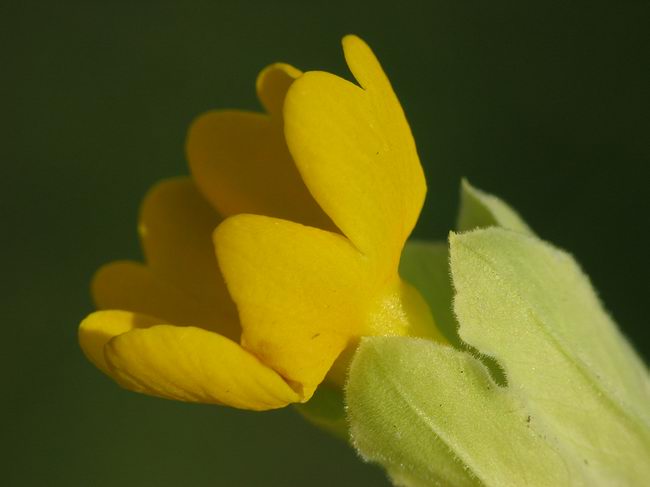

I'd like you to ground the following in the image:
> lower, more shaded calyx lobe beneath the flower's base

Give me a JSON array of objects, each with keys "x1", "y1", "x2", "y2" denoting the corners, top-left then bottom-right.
[{"x1": 347, "y1": 337, "x2": 578, "y2": 486}]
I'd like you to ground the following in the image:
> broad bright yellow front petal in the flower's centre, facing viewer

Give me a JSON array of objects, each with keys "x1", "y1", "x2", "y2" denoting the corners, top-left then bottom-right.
[{"x1": 215, "y1": 215, "x2": 374, "y2": 398}]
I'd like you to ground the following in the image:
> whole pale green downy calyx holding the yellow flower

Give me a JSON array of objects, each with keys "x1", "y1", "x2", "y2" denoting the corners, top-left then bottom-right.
[{"x1": 346, "y1": 185, "x2": 650, "y2": 487}]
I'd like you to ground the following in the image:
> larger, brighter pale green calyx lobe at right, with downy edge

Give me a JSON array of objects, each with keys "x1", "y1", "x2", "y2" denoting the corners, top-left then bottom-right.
[{"x1": 450, "y1": 228, "x2": 650, "y2": 485}]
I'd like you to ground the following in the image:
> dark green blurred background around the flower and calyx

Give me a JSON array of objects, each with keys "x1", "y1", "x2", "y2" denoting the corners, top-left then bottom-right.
[{"x1": 0, "y1": 0, "x2": 650, "y2": 487}]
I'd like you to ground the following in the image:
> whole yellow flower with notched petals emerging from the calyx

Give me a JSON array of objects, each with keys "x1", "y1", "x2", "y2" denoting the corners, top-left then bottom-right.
[{"x1": 79, "y1": 36, "x2": 439, "y2": 410}]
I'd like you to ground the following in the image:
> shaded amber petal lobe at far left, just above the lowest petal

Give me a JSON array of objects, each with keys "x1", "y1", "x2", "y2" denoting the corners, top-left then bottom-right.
[{"x1": 92, "y1": 261, "x2": 241, "y2": 340}]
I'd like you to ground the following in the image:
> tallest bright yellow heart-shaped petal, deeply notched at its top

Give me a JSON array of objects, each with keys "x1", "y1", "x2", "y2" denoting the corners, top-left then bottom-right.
[{"x1": 284, "y1": 36, "x2": 426, "y2": 275}]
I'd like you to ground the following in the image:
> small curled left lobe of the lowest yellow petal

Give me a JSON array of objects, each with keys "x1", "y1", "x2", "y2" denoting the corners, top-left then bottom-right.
[{"x1": 79, "y1": 311, "x2": 161, "y2": 375}]
